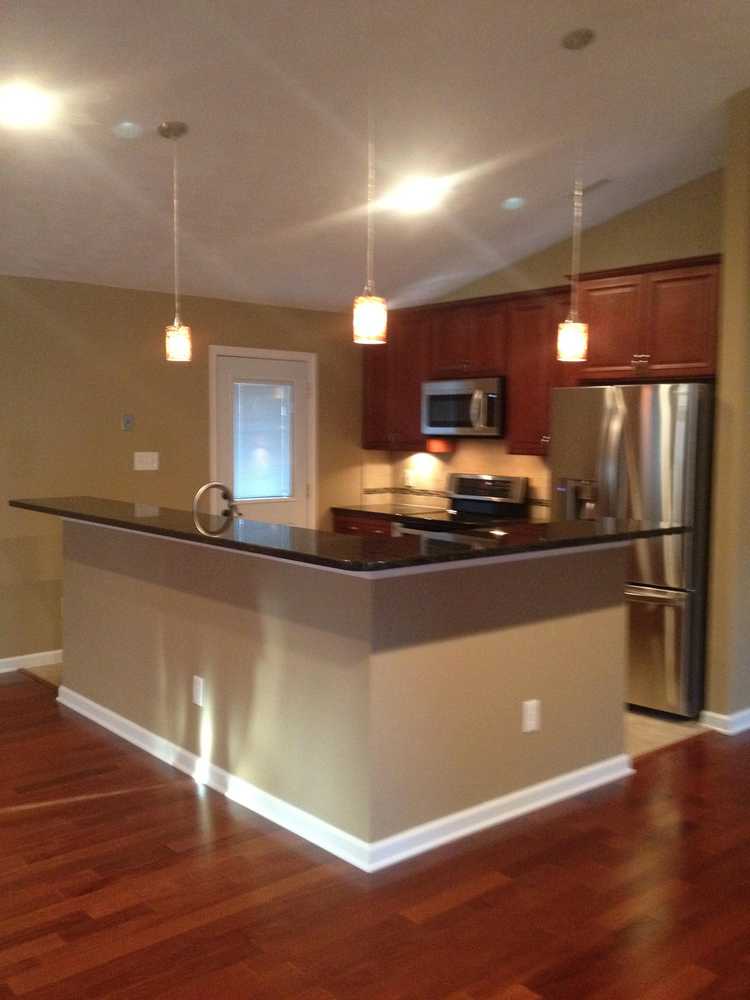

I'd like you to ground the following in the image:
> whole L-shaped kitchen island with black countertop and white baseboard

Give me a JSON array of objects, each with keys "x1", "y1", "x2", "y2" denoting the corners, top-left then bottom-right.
[{"x1": 11, "y1": 497, "x2": 682, "y2": 871}]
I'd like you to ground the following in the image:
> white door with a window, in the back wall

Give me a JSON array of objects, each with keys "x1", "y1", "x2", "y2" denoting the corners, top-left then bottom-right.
[{"x1": 212, "y1": 348, "x2": 316, "y2": 527}]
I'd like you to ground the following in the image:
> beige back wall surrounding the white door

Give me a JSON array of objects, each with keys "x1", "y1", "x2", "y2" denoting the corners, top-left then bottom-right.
[{"x1": 0, "y1": 277, "x2": 361, "y2": 659}]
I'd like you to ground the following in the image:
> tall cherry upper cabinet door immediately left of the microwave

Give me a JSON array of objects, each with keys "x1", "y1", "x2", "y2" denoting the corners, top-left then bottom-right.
[{"x1": 386, "y1": 310, "x2": 432, "y2": 451}]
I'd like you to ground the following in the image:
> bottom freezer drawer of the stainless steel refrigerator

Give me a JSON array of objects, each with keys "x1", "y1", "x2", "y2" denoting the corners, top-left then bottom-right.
[{"x1": 625, "y1": 587, "x2": 695, "y2": 715}]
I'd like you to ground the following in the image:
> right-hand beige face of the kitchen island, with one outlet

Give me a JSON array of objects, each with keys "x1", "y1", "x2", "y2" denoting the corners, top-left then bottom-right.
[{"x1": 370, "y1": 548, "x2": 627, "y2": 840}]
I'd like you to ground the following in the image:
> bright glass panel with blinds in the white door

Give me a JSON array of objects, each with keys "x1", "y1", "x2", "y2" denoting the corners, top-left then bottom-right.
[{"x1": 233, "y1": 382, "x2": 294, "y2": 500}]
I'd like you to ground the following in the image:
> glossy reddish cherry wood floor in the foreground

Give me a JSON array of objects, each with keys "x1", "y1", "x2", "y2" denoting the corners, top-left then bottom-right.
[{"x1": 0, "y1": 674, "x2": 750, "y2": 1000}]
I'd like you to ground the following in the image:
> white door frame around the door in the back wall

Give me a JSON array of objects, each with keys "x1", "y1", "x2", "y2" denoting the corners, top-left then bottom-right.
[{"x1": 208, "y1": 344, "x2": 318, "y2": 528}]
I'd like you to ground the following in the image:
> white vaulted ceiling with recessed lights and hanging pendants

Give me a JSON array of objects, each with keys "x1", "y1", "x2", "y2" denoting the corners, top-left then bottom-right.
[{"x1": 0, "y1": 0, "x2": 750, "y2": 309}]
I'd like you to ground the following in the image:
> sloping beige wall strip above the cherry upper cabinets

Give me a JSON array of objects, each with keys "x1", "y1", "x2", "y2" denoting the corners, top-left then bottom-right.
[{"x1": 444, "y1": 170, "x2": 722, "y2": 300}]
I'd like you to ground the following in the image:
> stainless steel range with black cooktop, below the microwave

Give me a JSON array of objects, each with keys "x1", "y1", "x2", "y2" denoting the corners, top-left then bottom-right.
[{"x1": 394, "y1": 473, "x2": 529, "y2": 535}]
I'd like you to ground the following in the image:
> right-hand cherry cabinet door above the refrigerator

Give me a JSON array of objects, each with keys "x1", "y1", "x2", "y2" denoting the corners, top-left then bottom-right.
[{"x1": 644, "y1": 265, "x2": 719, "y2": 378}]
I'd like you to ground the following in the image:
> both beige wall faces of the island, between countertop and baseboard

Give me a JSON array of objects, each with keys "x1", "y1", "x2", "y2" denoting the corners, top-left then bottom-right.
[{"x1": 63, "y1": 523, "x2": 626, "y2": 841}]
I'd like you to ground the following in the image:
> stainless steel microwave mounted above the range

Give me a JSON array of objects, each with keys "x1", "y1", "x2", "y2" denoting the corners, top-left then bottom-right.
[{"x1": 422, "y1": 377, "x2": 505, "y2": 437}]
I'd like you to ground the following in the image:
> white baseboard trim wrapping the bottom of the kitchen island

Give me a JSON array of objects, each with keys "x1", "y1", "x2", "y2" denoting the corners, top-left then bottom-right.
[{"x1": 57, "y1": 687, "x2": 633, "y2": 872}]
